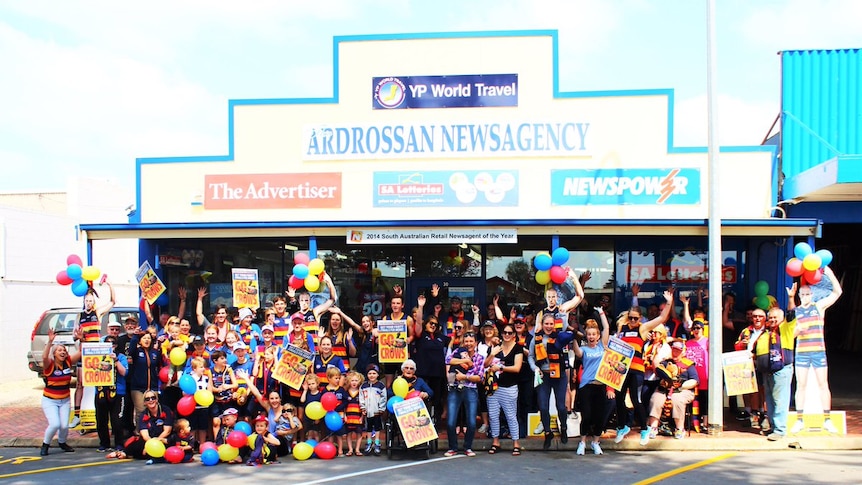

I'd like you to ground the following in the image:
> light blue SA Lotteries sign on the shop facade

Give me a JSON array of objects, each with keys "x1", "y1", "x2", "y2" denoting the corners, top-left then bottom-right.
[{"x1": 374, "y1": 170, "x2": 518, "y2": 207}]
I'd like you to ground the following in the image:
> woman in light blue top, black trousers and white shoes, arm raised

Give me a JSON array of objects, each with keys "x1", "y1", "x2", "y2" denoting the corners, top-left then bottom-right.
[{"x1": 572, "y1": 307, "x2": 616, "y2": 455}]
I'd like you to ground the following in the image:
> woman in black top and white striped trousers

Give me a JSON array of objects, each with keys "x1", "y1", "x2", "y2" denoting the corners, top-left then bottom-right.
[{"x1": 485, "y1": 323, "x2": 524, "y2": 456}]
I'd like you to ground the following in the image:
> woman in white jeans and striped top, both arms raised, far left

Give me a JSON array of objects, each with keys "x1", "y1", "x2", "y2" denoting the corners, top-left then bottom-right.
[{"x1": 39, "y1": 330, "x2": 81, "y2": 456}]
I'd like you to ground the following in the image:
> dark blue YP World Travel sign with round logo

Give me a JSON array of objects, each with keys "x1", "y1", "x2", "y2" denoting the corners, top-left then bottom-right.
[{"x1": 371, "y1": 74, "x2": 518, "y2": 109}]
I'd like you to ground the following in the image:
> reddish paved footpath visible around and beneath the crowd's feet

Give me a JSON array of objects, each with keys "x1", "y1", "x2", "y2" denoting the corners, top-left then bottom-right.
[{"x1": 0, "y1": 379, "x2": 862, "y2": 452}]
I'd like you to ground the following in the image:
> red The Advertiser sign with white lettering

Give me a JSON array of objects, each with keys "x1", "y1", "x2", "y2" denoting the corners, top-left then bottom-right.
[{"x1": 204, "y1": 172, "x2": 341, "y2": 210}]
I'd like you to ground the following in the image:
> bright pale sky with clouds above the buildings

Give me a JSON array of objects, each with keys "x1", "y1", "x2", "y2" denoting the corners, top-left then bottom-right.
[{"x1": 0, "y1": 0, "x2": 862, "y2": 192}]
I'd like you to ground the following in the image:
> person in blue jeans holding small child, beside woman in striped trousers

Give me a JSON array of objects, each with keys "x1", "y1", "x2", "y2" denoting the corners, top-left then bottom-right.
[{"x1": 444, "y1": 330, "x2": 485, "y2": 457}]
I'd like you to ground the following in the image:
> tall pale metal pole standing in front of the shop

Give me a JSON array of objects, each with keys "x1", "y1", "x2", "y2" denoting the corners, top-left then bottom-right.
[{"x1": 706, "y1": 0, "x2": 724, "y2": 436}]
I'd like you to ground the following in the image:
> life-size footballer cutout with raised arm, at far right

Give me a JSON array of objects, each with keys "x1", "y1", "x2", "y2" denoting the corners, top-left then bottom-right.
[{"x1": 788, "y1": 266, "x2": 842, "y2": 434}]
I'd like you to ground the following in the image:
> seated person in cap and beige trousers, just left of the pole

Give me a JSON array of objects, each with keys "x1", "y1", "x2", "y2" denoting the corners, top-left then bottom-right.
[{"x1": 641, "y1": 340, "x2": 698, "y2": 445}]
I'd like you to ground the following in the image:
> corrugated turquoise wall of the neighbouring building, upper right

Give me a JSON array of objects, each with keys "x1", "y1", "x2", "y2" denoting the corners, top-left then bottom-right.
[{"x1": 781, "y1": 49, "x2": 862, "y2": 177}]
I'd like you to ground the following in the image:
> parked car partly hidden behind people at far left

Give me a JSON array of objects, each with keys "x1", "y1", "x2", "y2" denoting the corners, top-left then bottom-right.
[{"x1": 27, "y1": 307, "x2": 142, "y2": 377}]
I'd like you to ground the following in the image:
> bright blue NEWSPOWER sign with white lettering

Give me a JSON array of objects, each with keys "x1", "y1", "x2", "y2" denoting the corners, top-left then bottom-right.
[{"x1": 551, "y1": 168, "x2": 700, "y2": 205}]
